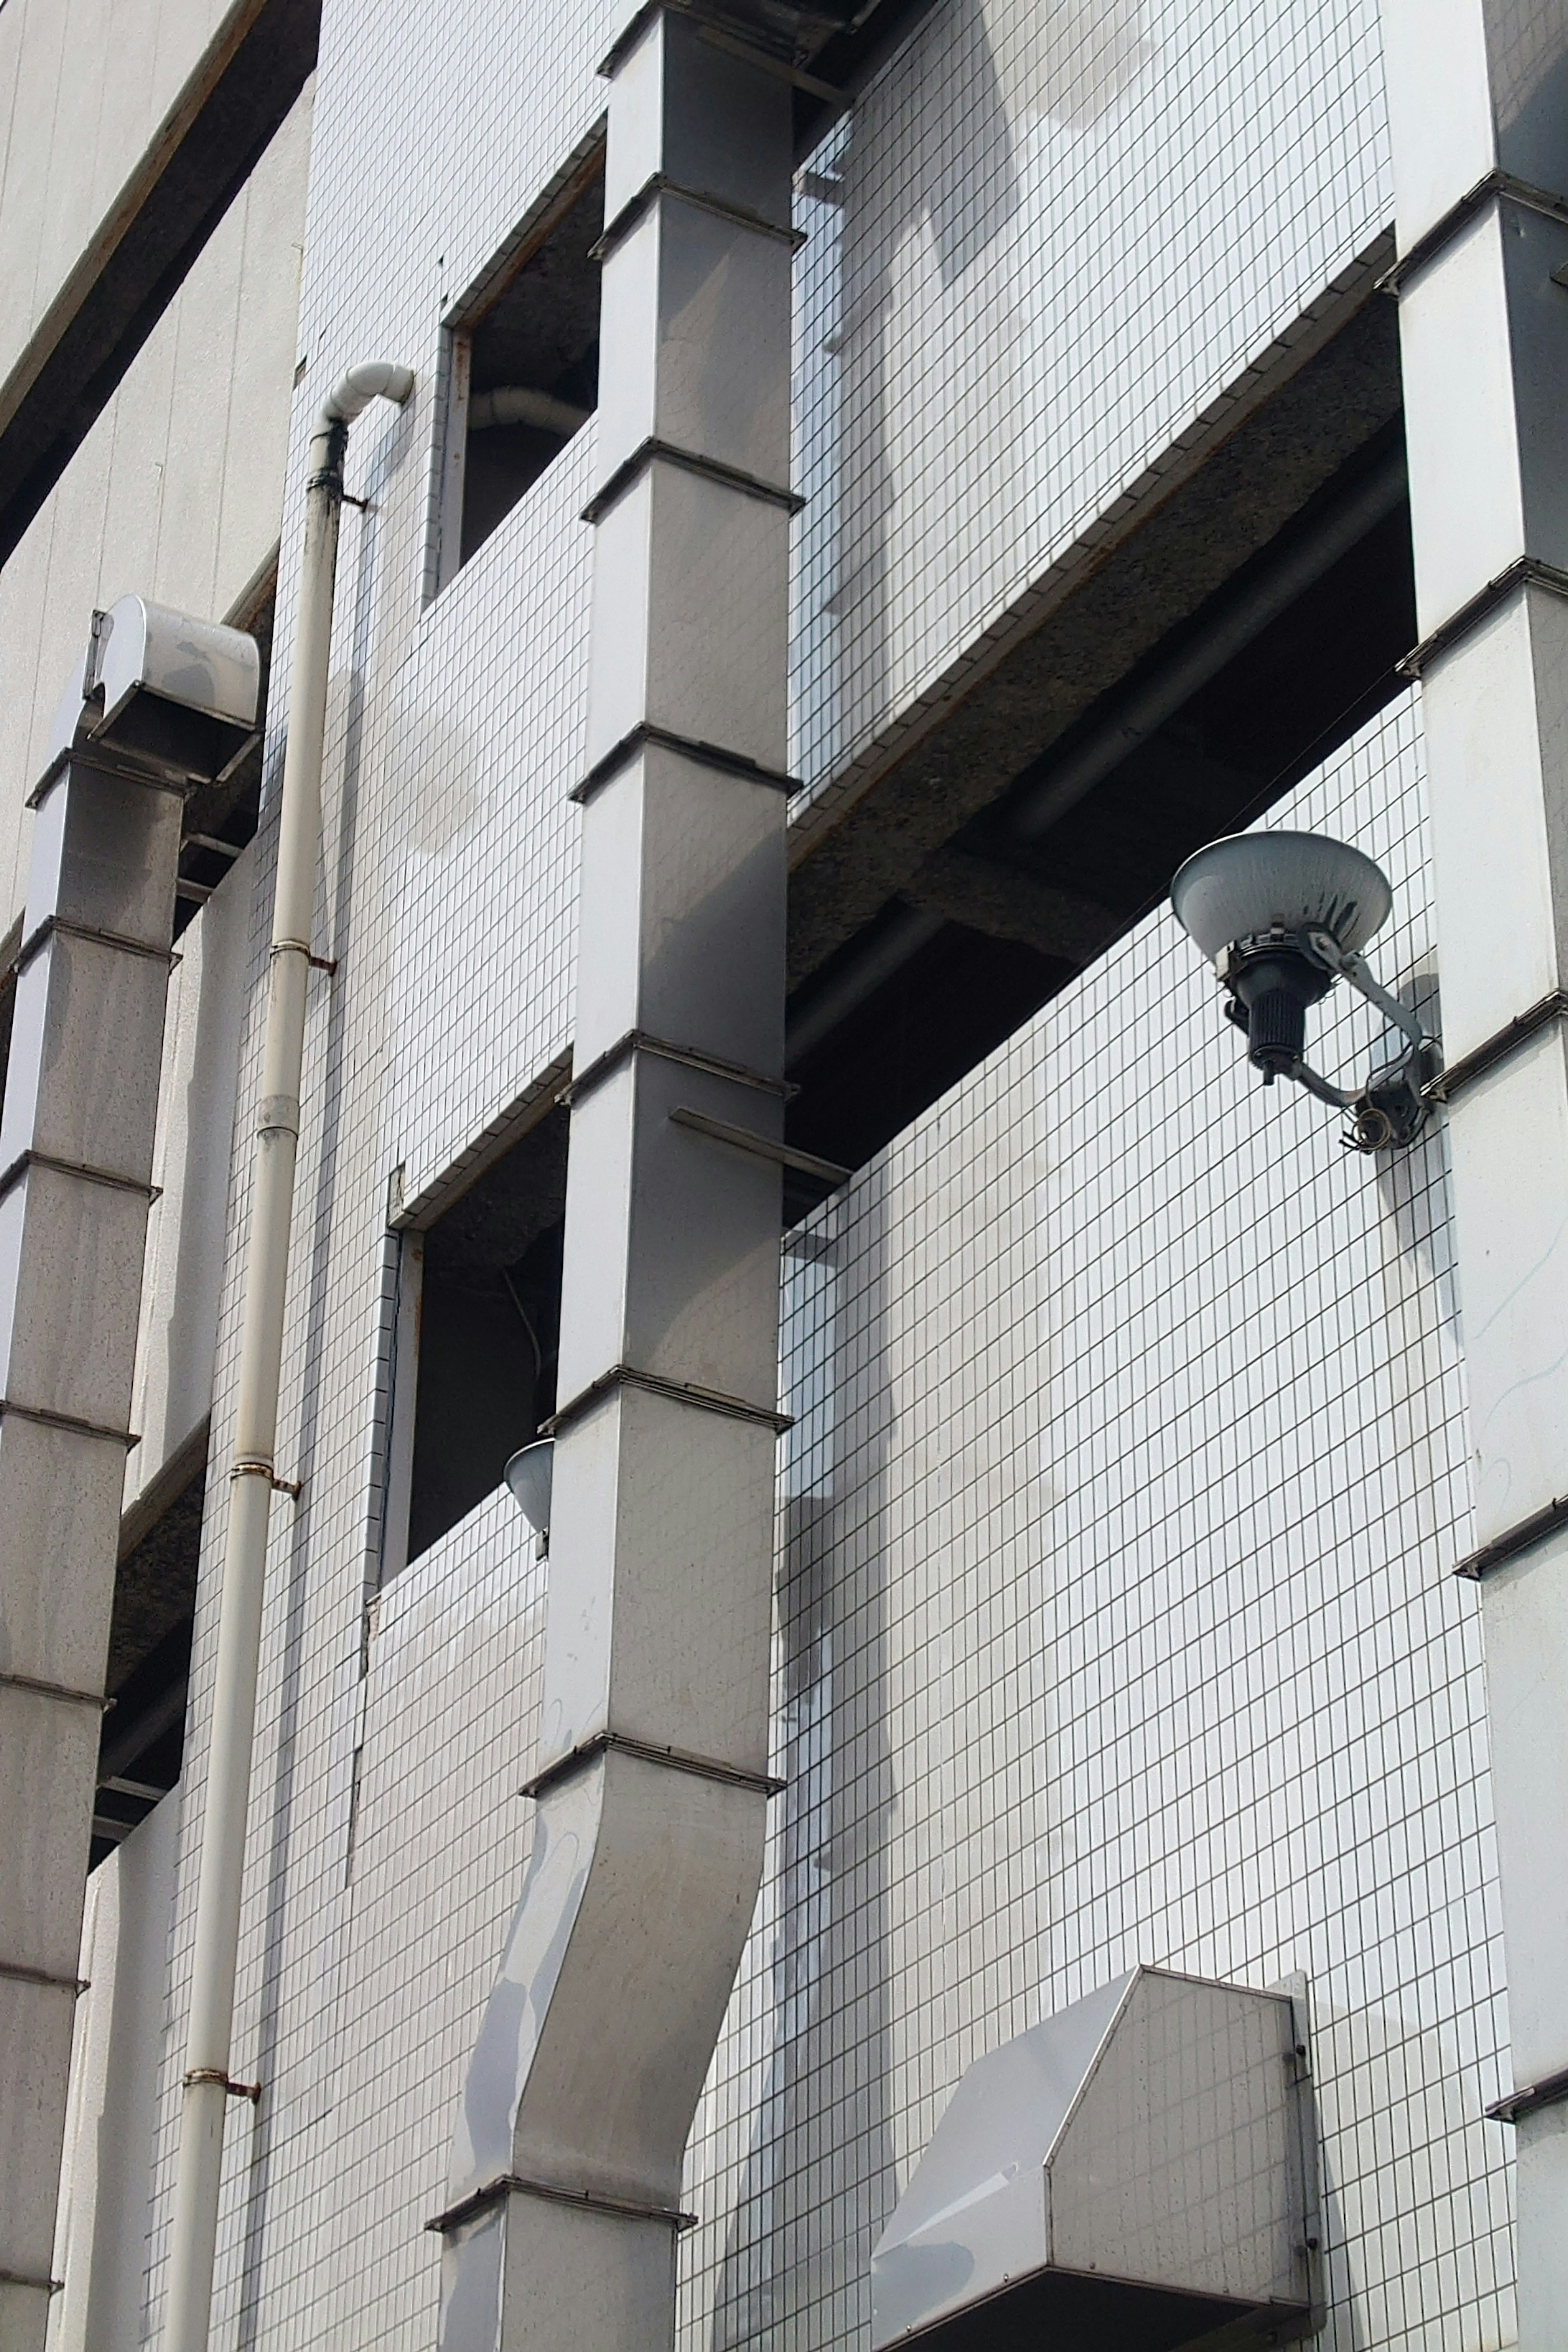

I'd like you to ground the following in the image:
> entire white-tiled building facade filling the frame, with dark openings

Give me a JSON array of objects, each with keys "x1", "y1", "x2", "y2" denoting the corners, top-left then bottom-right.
[{"x1": 0, "y1": 0, "x2": 1568, "y2": 2352}]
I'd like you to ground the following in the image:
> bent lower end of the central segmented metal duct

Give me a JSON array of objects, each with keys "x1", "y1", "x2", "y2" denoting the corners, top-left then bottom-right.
[{"x1": 430, "y1": 1752, "x2": 766, "y2": 2352}]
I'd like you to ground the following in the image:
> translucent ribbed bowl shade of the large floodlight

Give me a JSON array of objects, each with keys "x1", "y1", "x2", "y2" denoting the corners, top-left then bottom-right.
[{"x1": 1171, "y1": 833, "x2": 1394, "y2": 957}]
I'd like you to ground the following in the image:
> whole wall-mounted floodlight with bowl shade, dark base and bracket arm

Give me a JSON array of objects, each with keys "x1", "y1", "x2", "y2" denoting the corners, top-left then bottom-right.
[{"x1": 1171, "y1": 833, "x2": 1443, "y2": 1152}]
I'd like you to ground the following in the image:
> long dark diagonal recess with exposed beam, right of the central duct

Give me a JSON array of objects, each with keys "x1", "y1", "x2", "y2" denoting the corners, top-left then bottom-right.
[{"x1": 790, "y1": 240, "x2": 1413, "y2": 1195}]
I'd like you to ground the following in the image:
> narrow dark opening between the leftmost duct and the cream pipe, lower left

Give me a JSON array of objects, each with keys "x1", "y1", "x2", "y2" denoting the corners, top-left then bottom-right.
[{"x1": 89, "y1": 1421, "x2": 209, "y2": 1870}]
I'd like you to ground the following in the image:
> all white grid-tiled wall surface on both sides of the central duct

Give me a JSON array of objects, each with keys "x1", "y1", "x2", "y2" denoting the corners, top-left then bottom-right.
[{"x1": 116, "y1": 0, "x2": 1507, "y2": 2352}]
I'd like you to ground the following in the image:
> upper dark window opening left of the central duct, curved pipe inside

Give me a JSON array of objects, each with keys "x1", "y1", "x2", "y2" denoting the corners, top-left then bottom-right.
[{"x1": 451, "y1": 151, "x2": 604, "y2": 564}]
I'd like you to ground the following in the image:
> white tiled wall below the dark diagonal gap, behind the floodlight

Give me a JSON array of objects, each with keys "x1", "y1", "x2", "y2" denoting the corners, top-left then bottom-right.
[{"x1": 682, "y1": 699, "x2": 1512, "y2": 2352}]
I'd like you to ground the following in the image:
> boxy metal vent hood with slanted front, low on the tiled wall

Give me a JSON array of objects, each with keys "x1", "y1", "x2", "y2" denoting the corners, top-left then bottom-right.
[{"x1": 872, "y1": 1969, "x2": 1316, "y2": 2352}]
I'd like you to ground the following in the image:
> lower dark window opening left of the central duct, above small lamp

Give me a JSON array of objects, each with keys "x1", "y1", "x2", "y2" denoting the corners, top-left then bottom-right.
[{"x1": 407, "y1": 1108, "x2": 566, "y2": 1559}]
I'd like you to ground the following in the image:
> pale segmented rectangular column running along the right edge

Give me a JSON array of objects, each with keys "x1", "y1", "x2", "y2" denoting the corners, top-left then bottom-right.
[{"x1": 1382, "y1": 0, "x2": 1568, "y2": 2323}]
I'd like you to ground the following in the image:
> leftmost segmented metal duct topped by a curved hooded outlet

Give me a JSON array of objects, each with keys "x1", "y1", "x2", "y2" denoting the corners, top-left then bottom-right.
[{"x1": 0, "y1": 597, "x2": 258, "y2": 2352}]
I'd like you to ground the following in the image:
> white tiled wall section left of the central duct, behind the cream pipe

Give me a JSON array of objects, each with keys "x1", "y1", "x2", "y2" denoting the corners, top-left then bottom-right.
[{"x1": 146, "y1": 0, "x2": 625, "y2": 2352}]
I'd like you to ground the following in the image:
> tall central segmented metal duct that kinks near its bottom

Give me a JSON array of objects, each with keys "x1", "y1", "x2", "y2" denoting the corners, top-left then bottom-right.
[{"x1": 432, "y1": 7, "x2": 797, "y2": 2352}]
